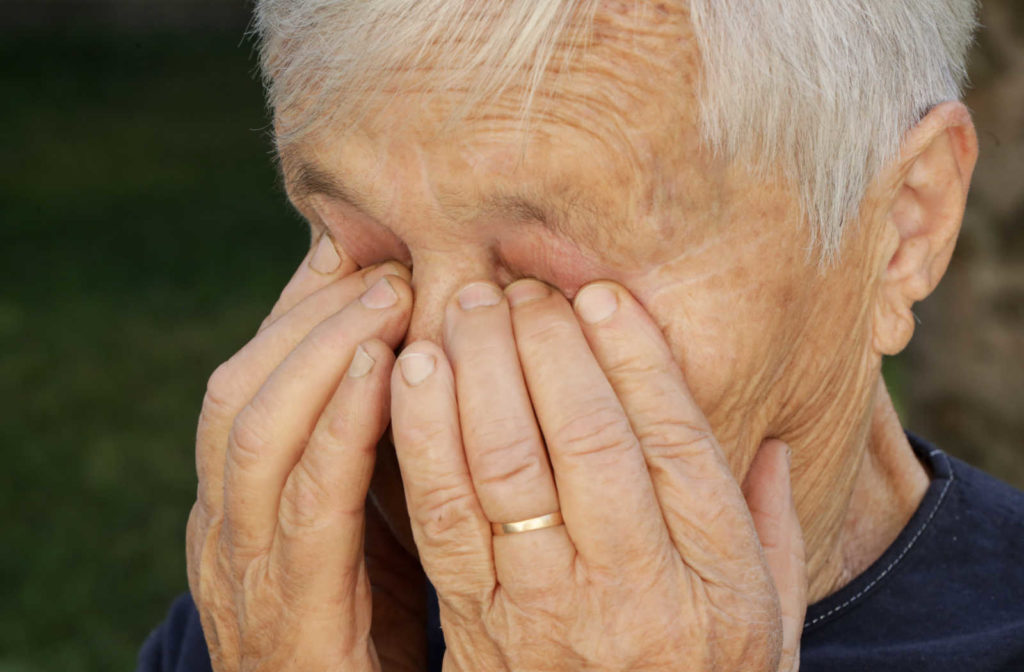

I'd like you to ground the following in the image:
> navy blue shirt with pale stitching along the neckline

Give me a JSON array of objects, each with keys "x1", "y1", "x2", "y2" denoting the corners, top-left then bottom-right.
[{"x1": 137, "y1": 434, "x2": 1024, "y2": 672}]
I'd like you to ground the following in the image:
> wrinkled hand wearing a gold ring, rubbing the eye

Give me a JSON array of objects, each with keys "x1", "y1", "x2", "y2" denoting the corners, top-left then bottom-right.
[{"x1": 391, "y1": 281, "x2": 806, "y2": 672}]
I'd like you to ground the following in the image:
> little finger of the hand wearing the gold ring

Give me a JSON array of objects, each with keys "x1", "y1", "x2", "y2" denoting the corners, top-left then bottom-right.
[{"x1": 391, "y1": 341, "x2": 495, "y2": 608}]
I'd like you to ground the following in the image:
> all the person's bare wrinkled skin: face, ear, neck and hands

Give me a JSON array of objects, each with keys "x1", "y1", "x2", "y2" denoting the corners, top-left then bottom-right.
[{"x1": 188, "y1": 1, "x2": 976, "y2": 672}]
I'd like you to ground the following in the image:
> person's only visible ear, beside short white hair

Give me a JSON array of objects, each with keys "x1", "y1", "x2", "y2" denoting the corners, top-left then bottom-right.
[{"x1": 873, "y1": 102, "x2": 978, "y2": 354}]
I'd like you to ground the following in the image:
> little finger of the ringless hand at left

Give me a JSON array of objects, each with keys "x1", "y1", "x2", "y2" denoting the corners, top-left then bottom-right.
[{"x1": 271, "y1": 339, "x2": 394, "y2": 608}]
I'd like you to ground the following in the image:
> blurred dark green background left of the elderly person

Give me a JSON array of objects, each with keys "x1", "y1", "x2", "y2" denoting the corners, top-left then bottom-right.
[{"x1": 0, "y1": 21, "x2": 308, "y2": 672}]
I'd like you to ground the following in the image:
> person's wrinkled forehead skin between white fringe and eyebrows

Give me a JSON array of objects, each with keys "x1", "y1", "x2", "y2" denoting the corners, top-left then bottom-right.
[{"x1": 282, "y1": 3, "x2": 721, "y2": 263}]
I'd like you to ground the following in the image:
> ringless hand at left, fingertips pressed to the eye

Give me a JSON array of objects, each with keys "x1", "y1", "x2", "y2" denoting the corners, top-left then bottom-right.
[{"x1": 187, "y1": 232, "x2": 422, "y2": 672}]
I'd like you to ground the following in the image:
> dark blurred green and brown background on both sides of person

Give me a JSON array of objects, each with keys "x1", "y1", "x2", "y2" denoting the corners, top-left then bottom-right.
[{"x1": 0, "y1": 0, "x2": 1024, "y2": 672}]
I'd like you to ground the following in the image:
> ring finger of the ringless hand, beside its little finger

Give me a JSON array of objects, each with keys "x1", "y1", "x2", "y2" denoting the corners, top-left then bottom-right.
[{"x1": 224, "y1": 277, "x2": 412, "y2": 562}]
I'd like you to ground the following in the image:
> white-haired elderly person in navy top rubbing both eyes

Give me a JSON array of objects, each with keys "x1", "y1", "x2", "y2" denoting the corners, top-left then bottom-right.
[{"x1": 140, "y1": 0, "x2": 1024, "y2": 672}]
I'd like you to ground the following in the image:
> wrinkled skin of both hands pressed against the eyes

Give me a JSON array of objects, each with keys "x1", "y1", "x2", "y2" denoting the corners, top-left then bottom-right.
[{"x1": 188, "y1": 247, "x2": 806, "y2": 670}]
